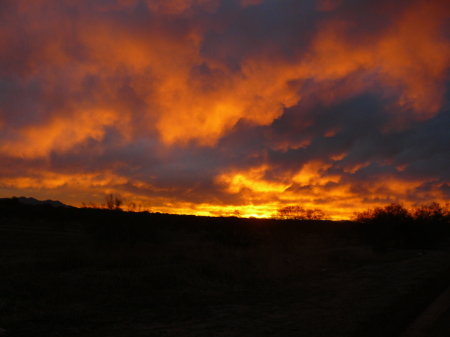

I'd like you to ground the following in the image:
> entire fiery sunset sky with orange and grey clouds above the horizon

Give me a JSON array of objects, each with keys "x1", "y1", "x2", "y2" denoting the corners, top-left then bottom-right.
[{"x1": 0, "y1": 0, "x2": 450, "y2": 220}]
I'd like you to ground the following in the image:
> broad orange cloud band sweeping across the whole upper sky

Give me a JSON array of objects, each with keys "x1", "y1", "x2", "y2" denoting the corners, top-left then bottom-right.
[{"x1": 5, "y1": 0, "x2": 450, "y2": 146}]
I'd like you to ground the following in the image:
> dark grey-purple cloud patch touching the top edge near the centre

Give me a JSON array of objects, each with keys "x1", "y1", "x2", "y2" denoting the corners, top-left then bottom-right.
[{"x1": 201, "y1": 1, "x2": 318, "y2": 71}]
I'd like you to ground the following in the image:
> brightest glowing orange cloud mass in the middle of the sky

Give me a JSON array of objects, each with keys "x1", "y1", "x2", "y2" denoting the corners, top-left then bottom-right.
[{"x1": 158, "y1": 59, "x2": 298, "y2": 146}]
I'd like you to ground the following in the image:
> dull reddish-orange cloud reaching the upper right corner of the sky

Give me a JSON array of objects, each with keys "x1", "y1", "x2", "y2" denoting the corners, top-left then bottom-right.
[{"x1": 303, "y1": 1, "x2": 450, "y2": 119}]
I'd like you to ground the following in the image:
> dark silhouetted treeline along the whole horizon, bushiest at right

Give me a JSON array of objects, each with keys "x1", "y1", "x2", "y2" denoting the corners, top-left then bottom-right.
[{"x1": 0, "y1": 195, "x2": 450, "y2": 251}]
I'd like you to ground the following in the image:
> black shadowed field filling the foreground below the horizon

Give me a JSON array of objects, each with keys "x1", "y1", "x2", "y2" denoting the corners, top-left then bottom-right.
[{"x1": 0, "y1": 202, "x2": 450, "y2": 337}]
